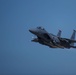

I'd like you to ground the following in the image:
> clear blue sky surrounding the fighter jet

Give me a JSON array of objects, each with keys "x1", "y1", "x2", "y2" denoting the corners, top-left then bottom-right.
[{"x1": 0, "y1": 0, "x2": 76, "y2": 75}]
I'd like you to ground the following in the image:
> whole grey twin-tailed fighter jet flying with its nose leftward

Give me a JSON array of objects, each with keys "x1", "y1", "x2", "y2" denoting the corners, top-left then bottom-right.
[{"x1": 29, "y1": 27, "x2": 76, "y2": 49}]
